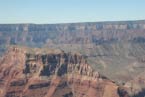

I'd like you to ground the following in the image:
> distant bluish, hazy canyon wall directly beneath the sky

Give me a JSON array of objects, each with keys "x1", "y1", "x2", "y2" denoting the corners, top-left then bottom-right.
[{"x1": 0, "y1": 20, "x2": 145, "y2": 46}]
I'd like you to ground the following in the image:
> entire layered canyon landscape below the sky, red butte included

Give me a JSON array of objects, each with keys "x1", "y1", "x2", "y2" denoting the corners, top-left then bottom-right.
[{"x1": 0, "y1": 20, "x2": 145, "y2": 97}]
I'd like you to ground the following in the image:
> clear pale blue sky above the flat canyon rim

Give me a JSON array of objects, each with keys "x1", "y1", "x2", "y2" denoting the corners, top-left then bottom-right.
[{"x1": 0, "y1": 0, "x2": 145, "y2": 23}]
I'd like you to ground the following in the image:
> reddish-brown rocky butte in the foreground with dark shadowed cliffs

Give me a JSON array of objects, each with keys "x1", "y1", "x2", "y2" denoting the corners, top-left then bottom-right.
[{"x1": 0, "y1": 47, "x2": 127, "y2": 97}]
